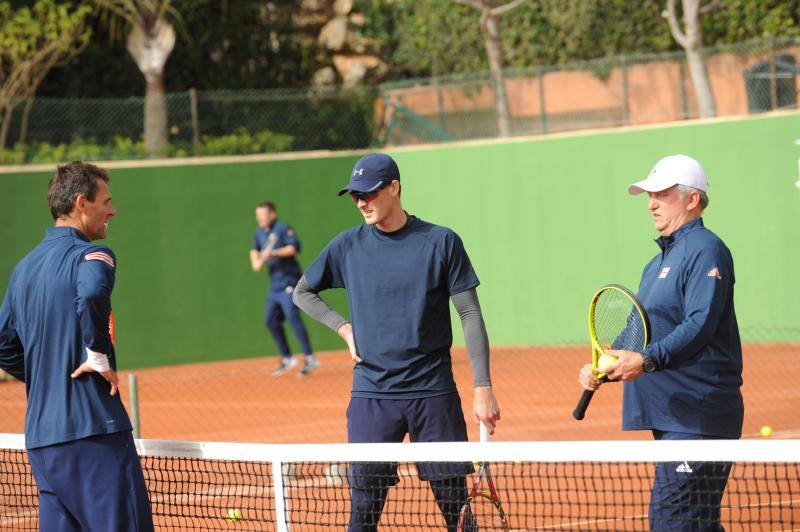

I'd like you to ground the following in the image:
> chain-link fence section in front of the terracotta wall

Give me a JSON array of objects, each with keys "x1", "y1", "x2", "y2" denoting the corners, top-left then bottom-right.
[{"x1": 380, "y1": 40, "x2": 800, "y2": 145}]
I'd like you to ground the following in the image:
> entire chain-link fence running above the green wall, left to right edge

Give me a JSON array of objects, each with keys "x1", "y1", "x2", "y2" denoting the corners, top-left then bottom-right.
[{"x1": 0, "y1": 40, "x2": 800, "y2": 164}]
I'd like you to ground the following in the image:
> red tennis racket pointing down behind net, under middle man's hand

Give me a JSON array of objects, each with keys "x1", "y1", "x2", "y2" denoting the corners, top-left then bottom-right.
[{"x1": 458, "y1": 423, "x2": 510, "y2": 532}]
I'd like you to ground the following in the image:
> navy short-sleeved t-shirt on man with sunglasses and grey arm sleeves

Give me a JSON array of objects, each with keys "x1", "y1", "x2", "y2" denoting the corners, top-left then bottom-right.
[{"x1": 305, "y1": 216, "x2": 479, "y2": 399}]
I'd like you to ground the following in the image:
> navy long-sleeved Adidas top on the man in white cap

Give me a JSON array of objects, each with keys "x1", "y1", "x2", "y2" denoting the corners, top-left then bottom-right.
[{"x1": 622, "y1": 219, "x2": 744, "y2": 438}]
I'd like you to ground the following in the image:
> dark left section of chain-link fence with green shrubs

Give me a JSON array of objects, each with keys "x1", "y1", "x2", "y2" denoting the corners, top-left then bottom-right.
[{"x1": 0, "y1": 87, "x2": 378, "y2": 164}]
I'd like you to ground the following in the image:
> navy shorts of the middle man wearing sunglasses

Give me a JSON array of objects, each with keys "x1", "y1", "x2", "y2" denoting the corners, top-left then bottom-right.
[{"x1": 347, "y1": 392, "x2": 475, "y2": 489}]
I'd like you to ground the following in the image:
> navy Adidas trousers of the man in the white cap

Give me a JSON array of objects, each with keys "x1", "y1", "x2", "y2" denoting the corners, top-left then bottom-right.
[{"x1": 649, "y1": 430, "x2": 731, "y2": 532}]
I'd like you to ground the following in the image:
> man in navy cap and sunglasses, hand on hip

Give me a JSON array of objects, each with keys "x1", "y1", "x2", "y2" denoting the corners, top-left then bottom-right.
[{"x1": 294, "y1": 153, "x2": 500, "y2": 531}]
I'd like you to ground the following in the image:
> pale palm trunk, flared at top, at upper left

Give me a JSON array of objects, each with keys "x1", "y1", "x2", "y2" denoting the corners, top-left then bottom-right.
[{"x1": 94, "y1": 0, "x2": 180, "y2": 157}]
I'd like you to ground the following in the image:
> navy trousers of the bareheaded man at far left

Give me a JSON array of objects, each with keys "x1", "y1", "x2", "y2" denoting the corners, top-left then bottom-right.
[{"x1": 28, "y1": 431, "x2": 153, "y2": 532}]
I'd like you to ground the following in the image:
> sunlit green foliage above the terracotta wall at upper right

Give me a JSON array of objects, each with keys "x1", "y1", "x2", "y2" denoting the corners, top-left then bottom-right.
[{"x1": 356, "y1": 0, "x2": 800, "y2": 76}]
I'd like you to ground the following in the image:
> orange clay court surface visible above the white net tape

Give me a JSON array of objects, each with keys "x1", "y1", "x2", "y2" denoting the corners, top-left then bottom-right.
[{"x1": 0, "y1": 343, "x2": 800, "y2": 443}]
